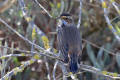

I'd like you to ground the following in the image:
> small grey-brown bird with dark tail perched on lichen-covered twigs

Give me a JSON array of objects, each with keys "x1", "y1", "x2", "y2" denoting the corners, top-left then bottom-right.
[{"x1": 57, "y1": 13, "x2": 82, "y2": 73}]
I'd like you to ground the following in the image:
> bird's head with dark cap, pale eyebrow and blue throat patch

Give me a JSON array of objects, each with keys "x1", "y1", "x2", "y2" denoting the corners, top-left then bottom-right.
[{"x1": 59, "y1": 13, "x2": 73, "y2": 25}]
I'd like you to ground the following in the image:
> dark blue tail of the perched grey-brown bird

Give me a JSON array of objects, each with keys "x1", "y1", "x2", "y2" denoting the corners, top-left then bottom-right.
[{"x1": 69, "y1": 54, "x2": 78, "y2": 73}]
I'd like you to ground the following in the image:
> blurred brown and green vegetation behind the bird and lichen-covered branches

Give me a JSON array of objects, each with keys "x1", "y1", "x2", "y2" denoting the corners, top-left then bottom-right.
[{"x1": 0, "y1": 0, "x2": 120, "y2": 80}]
